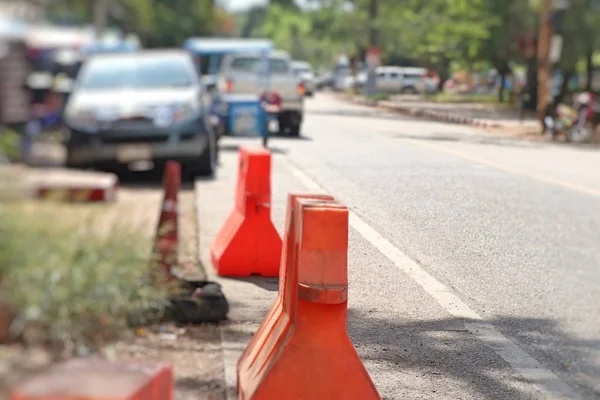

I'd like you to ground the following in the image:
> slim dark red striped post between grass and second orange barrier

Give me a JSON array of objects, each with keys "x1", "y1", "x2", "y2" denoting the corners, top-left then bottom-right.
[{"x1": 152, "y1": 161, "x2": 181, "y2": 279}]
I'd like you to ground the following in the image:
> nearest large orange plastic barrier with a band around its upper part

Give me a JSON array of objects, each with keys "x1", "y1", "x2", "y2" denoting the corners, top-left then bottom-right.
[{"x1": 237, "y1": 195, "x2": 381, "y2": 400}]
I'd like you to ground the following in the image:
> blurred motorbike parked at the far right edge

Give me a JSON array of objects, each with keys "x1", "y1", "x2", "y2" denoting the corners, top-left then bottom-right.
[{"x1": 542, "y1": 92, "x2": 600, "y2": 142}]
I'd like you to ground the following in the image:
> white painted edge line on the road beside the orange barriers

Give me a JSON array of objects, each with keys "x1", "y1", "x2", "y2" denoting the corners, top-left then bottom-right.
[{"x1": 281, "y1": 157, "x2": 580, "y2": 400}]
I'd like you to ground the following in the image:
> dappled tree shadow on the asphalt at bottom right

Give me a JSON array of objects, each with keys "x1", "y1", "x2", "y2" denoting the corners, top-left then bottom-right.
[{"x1": 348, "y1": 309, "x2": 600, "y2": 400}]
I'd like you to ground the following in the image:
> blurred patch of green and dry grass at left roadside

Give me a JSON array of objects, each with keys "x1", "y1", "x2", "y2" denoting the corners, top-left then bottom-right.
[{"x1": 0, "y1": 197, "x2": 166, "y2": 351}]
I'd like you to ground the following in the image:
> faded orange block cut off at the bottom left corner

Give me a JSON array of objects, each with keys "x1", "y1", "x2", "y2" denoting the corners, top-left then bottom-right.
[{"x1": 10, "y1": 359, "x2": 174, "y2": 400}]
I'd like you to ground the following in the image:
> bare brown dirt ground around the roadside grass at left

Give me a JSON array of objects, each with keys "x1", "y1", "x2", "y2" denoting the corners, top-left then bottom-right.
[{"x1": 0, "y1": 166, "x2": 225, "y2": 400}]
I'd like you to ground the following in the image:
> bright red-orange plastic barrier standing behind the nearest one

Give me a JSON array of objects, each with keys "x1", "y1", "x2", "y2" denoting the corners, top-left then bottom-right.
[{"x1": 211, "y1": 148, "x2": 282, "y2": 277}]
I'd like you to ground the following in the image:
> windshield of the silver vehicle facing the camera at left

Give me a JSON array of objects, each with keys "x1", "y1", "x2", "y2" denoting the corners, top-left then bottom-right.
[{"x1": 79, "y1": 57, "x2": 193, "y2": 90}]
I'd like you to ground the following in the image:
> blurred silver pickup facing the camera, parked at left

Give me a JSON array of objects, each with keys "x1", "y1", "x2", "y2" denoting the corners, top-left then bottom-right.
[{"x1": 65, "y1": 50, "x2": 217, "y2": 176}]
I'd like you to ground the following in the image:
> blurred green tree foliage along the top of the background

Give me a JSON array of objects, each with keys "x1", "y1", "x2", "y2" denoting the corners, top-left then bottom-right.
[{"x1": 51, "y1": 0, "x2": 600, "y2": 94}]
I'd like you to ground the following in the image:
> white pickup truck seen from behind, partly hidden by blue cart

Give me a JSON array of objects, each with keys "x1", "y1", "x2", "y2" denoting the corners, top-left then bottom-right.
[{"x1": 217, "y1": 51, "x2": 306, "y2": 136}]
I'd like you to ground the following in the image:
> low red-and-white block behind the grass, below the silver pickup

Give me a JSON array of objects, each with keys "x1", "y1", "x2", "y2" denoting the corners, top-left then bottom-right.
[{"x1": 34, "y1": 175, "x2": 119, "y2": 203}]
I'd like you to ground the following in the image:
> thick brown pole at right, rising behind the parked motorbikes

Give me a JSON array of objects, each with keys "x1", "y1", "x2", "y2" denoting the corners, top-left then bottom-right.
[{"x1": 537, "y1": 0, "x2": 552, "y2": 119}]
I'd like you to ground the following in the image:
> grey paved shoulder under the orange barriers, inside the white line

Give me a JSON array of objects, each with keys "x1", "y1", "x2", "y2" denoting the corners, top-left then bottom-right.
[{"x1": 196, "y1": 146, "x2": 547, "y2": 399}]
